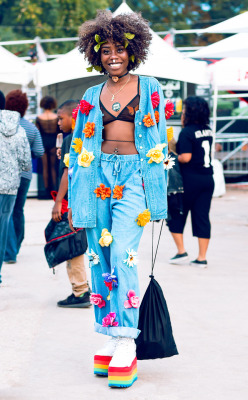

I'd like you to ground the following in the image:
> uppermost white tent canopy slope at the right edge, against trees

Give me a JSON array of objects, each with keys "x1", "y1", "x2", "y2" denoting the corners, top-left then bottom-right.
[{"x1": 204, "y1": 11, "x2": 248, "y2": 33}]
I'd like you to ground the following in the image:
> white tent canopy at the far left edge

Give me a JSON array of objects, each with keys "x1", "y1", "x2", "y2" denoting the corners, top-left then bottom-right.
[{"x1": 0, "y1": 46, "x2": 34, "y2": 86}]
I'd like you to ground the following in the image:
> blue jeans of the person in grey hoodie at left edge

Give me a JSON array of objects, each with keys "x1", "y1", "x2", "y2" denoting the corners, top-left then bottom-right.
[{"x1": 0, "y1": 194, "x2": 16, "y2": 283}]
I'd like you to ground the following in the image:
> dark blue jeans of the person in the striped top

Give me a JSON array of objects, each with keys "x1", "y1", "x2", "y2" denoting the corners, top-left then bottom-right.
[{"x1": 4, "y1": 178, "x2": 31, "y2": 261}]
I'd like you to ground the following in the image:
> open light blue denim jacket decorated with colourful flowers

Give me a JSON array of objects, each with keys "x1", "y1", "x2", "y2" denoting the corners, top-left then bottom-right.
[{"x1": 68, "y1": 76, "x2": 167, "y2": 228}]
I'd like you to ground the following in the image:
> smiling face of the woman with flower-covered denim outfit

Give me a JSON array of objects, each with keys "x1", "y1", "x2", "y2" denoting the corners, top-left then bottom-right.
[{"x1": 101, "y1": 40, "x2": 129, "y2": 76}]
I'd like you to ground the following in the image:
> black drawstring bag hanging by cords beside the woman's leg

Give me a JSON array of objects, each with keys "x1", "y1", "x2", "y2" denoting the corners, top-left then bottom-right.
[{"x1": 136, "y1": 220, "x2": 178, "y2": 360}]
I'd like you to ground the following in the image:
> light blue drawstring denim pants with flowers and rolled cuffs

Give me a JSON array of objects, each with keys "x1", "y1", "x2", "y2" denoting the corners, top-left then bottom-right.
[{"x1": 86, "y1": 153, "x2": 147, "y2": 338}]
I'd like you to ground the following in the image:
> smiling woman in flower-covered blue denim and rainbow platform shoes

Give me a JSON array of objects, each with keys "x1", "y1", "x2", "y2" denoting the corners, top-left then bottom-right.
[{"x1": 68, "y1": 11, "x2": 167, "y2": 387}]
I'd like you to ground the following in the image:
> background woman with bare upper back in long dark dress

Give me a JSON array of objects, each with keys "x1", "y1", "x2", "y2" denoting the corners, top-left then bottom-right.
[{"x1": 36, "y1": 96, "x2": 59, "y2": 198}]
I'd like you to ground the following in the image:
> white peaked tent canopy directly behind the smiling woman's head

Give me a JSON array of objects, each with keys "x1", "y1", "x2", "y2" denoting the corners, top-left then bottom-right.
[{"x1": 36, "y1": 3, "x2": 208, "y2": 87}]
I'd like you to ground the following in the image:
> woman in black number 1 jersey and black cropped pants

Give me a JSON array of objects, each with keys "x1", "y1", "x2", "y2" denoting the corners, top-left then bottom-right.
[{"x1": 168, "y1": 96, "x2": 214, "y2": 268}]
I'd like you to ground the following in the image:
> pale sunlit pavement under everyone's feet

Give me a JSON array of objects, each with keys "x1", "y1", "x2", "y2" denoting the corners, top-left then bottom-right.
[{"x1": 0, "y1": 189, "x2": 248, "y2": 400}]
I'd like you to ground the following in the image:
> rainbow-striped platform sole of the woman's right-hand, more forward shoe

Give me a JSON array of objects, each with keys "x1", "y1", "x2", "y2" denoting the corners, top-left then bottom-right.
[{"x1": 108, "y1": 357, "x2": 138, "y2": 387}]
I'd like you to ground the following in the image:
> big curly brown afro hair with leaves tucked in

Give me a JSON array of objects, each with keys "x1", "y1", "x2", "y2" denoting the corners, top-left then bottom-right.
[{"x1": 78, "y1": 10, "x2": 152, "y2": 73}]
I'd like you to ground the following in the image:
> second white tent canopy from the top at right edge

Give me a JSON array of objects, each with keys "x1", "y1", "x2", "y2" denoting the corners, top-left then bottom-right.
[{"x1": 189, "y1": 33, "x2": 248, "y2": 58}]
